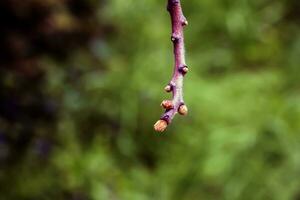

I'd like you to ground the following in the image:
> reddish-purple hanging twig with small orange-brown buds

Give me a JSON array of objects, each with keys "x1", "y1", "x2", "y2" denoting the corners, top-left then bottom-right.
[{"x1": 154, "y1": 0, "x2": 188, "y2": 132}]
